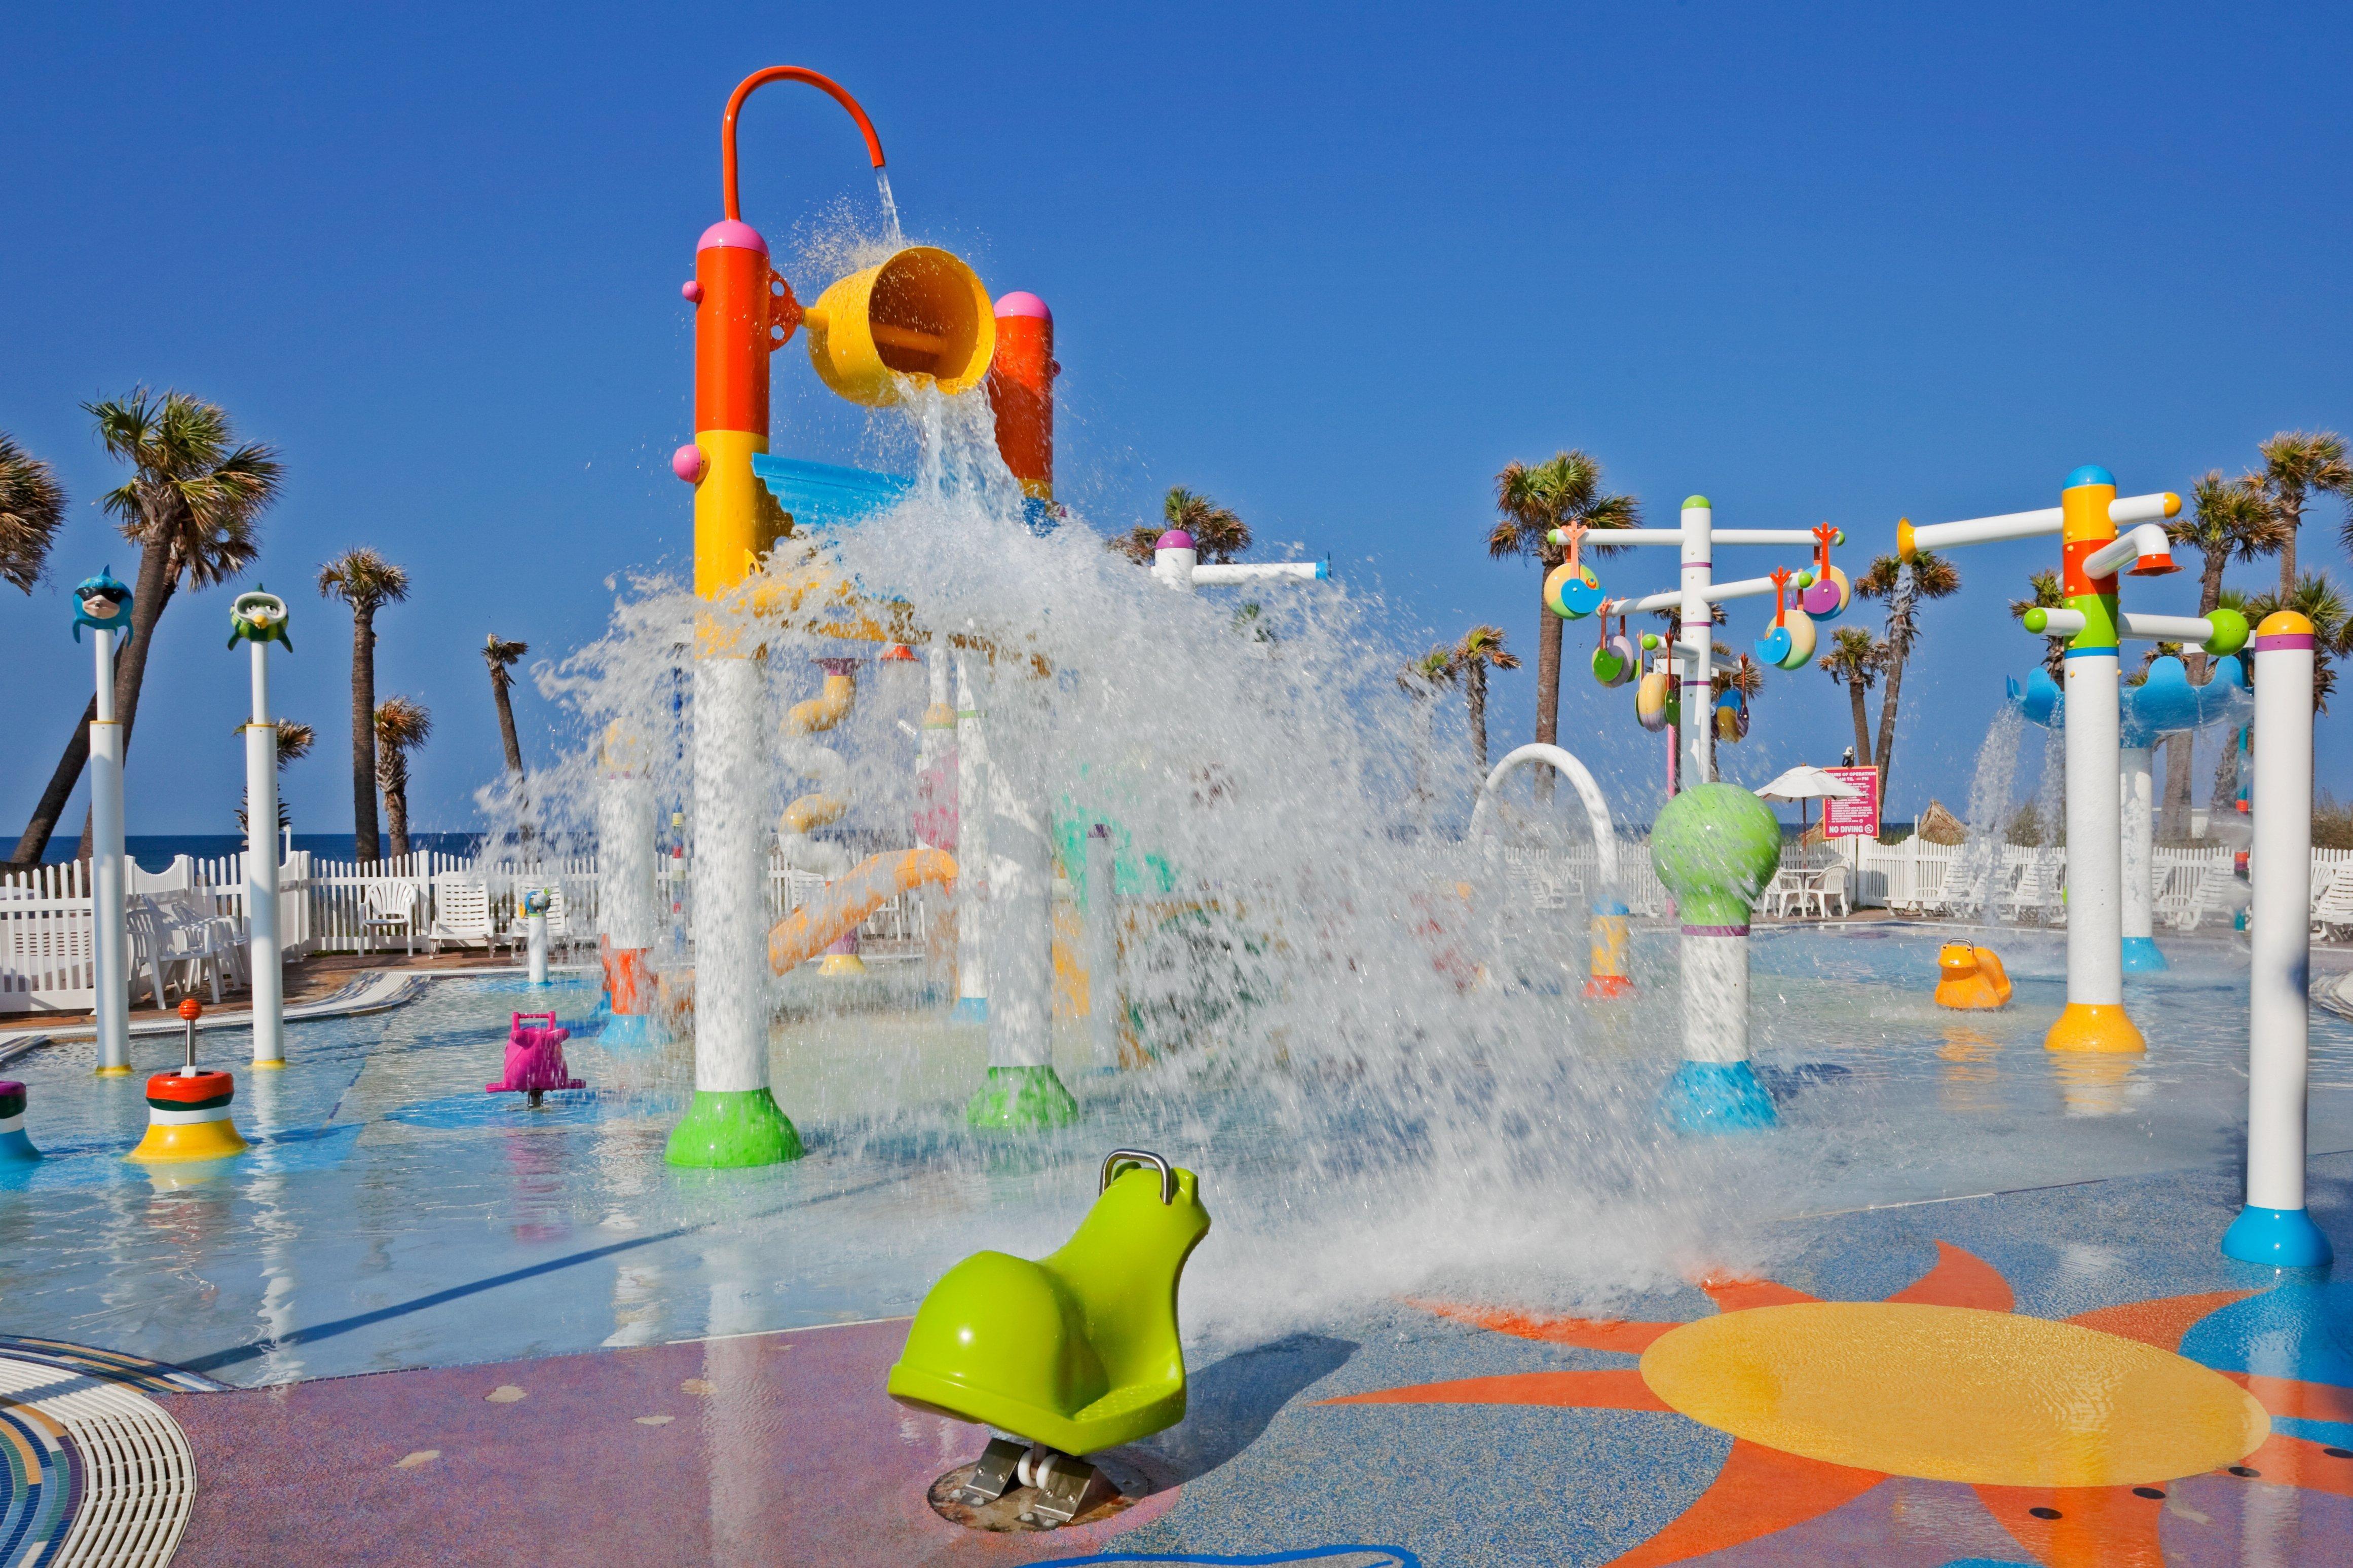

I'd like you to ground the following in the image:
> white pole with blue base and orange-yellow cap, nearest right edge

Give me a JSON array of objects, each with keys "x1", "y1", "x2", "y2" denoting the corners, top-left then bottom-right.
[{"x1": 2221, "y1": 611, "x2": 2330, "y2": 1267}]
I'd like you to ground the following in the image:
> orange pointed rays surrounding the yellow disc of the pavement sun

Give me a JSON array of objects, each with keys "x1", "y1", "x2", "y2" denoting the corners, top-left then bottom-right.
[{"x1": 1322, "y1": 1241, "x2": 2353, "y2": 1568}]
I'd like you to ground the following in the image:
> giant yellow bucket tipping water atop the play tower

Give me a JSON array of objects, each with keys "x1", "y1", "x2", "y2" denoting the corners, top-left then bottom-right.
[{"x1": 800, "y1": 245, "x2": 998, "y2": 407}]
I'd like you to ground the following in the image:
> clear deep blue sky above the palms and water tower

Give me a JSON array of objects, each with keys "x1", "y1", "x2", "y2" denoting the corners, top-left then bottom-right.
[{"x1": 0, "y1": 3, "x2": 2353, "y2": 839}]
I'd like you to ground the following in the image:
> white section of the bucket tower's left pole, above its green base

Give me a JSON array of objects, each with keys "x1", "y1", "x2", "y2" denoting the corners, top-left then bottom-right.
[{"x1": 687, "y1": 658, "x2": 767, "y2": 1093}]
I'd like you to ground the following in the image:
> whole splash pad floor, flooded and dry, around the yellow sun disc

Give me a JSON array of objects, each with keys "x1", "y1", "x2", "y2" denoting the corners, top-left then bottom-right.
[{"x1": 0, "y1": 926, "x2": 2353, "y2": 1568}]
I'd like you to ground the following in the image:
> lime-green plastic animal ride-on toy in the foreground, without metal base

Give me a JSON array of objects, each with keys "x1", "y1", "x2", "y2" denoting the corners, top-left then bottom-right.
[{"x1": 885, "y1": 1150, "x2": 1210, "y2": 1453}]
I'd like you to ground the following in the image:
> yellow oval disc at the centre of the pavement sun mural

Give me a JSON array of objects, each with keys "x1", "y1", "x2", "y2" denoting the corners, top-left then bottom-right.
[{"x1": 1642, "y1": 1303, "x2": 2270, "y2": 1486}]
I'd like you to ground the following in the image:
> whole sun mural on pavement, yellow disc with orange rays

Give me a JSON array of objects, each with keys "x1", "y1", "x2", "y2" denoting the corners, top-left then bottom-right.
[{"x1": 1325, "y1": 1241, "x2": 2353, "y2": 1568}]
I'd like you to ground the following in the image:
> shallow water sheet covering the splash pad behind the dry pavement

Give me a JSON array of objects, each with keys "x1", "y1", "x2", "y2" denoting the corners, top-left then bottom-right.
[{"x1": 0, "y1": 924, "x2": 2353, "y2": 1385}]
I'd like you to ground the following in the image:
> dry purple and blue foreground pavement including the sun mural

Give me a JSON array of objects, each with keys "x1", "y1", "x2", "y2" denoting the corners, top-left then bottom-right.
[{"x1": 142, "y1": 1154, "x2": 2353, "y2": 1568}]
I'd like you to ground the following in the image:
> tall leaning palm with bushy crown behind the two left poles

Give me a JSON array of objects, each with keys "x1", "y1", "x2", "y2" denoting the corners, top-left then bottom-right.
[{"x1": 17, "y1": 386, "x2": 285, "y2": 860}]
